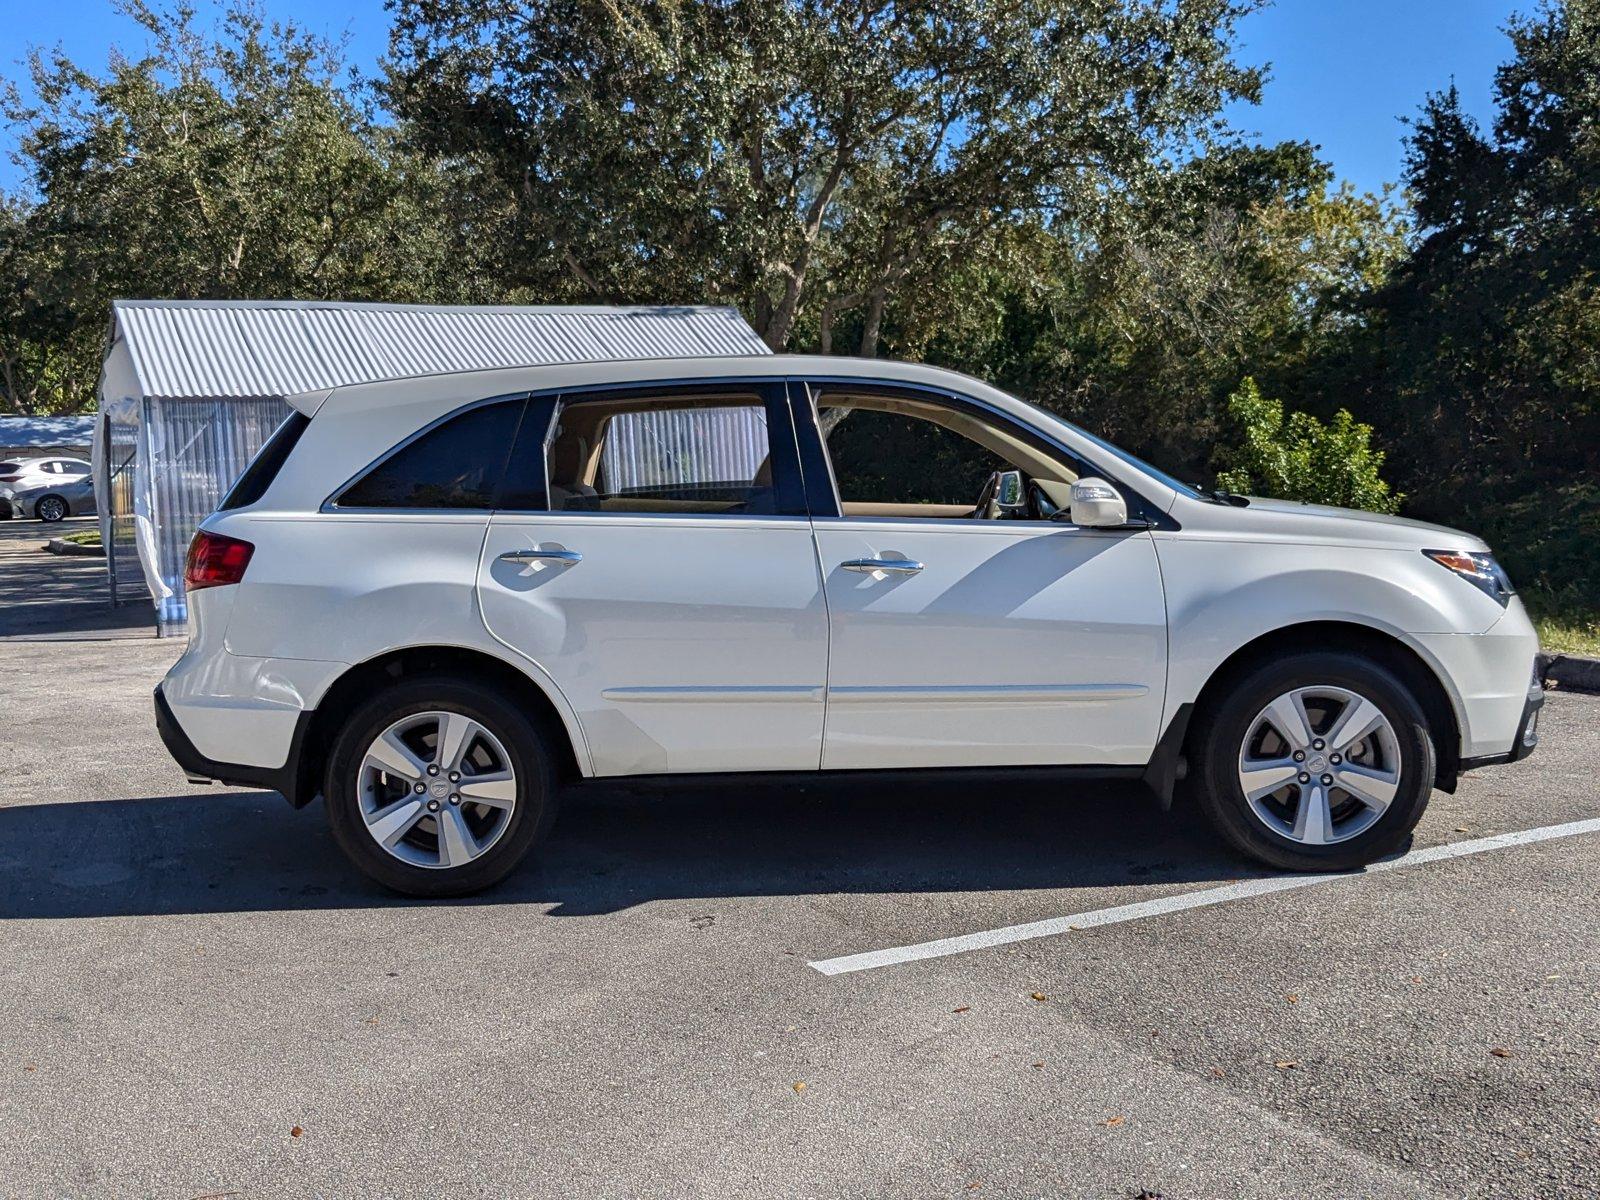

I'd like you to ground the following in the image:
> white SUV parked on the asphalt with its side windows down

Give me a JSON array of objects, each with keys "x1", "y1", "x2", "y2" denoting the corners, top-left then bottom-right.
[{"x1": 155, "y1": 357, "x2": 1542, "y2": 896}]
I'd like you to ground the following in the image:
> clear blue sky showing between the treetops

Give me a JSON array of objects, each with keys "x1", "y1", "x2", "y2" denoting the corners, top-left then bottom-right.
[{"x1": 0, "y1": 0, "x2": 1534, "y2": 190}]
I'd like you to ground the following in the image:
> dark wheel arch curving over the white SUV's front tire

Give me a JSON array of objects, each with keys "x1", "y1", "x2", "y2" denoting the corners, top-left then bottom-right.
[{"x1": 1184, "y1": 621, "x2": 1462, "y2": 792}]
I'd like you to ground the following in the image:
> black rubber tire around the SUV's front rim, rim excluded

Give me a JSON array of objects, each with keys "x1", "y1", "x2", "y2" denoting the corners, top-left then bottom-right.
[{"x1": 1194, "y1": 651, "x2": 1435, "y2": 870}]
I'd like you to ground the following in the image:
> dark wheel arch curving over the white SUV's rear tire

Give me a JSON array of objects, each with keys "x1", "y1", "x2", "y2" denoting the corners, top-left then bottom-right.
[{"x1": 288, "y1": 645, "x2": 589, "y2": 808}]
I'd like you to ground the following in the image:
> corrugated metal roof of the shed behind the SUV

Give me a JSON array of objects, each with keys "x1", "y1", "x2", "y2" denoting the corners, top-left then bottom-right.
[{"x1": 112, "y1": 301, "x2": 770, "y2": 398}]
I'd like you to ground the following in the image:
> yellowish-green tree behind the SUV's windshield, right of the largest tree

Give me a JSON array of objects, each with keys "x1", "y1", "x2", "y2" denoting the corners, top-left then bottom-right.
[{"x1": 921, "y1": 142, "x2": 1406, "y2": 478}]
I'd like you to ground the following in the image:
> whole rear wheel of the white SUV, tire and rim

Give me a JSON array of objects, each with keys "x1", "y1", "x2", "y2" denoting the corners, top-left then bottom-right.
[{"x1": 323, "y1": 675, "x2": 555, "y2": 896}]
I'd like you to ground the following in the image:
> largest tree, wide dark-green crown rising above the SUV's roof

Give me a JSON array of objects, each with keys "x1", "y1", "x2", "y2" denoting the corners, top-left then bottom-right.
[{"x1": 386, "y1": 0, "x2": 1259, "y2": 354}]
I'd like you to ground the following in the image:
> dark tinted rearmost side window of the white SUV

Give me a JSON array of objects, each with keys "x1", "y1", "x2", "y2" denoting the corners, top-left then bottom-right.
[{"x1": 336, "y1": 397, "x2": 523, "y2": 509}]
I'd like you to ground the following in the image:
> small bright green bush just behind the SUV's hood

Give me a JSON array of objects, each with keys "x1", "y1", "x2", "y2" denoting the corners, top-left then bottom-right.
[{"x1": 1216, "y1": 378, "x2": 1403, "y2": 512}]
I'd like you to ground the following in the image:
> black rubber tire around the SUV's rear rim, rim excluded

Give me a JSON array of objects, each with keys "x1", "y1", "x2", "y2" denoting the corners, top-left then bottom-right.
[{"x1": 323, "y1": 675, "x2": 557, "y2": 898}]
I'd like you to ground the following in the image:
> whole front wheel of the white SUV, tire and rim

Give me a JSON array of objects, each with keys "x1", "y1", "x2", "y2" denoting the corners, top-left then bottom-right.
[{"x1": 1197, "y1": 653, "x2": 1434, "y2": 870}]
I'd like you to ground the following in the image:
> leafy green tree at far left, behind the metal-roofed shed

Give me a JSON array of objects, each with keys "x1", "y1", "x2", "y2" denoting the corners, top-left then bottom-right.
[{"x1": 0, "y1": 0, "x2": 506, "y2": 411}]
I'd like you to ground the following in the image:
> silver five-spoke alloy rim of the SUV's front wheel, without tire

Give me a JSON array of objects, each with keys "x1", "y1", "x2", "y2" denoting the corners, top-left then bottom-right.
[{"x1": 1238, "y1": 685, "x2": 1400, "y2": 846}]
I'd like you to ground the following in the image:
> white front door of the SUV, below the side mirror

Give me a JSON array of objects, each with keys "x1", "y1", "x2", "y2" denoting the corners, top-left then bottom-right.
[{"x1": 797, "y1": 386, "x2": 1166, "y2": 770}]
